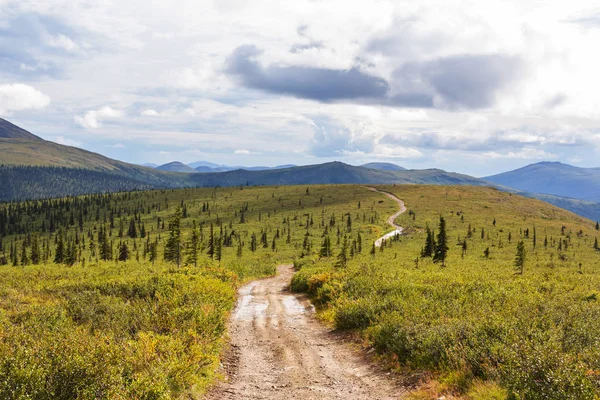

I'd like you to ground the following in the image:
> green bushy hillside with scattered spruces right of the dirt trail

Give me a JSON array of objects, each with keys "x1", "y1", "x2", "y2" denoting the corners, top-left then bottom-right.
[{"x1": 293, "y1": 186, "x2": 600, "y2": 399}]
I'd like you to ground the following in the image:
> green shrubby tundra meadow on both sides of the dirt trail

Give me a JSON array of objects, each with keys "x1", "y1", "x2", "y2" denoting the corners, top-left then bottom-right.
[{"x1": 0, "y1": 185, "x2": 600, "y2": 399}]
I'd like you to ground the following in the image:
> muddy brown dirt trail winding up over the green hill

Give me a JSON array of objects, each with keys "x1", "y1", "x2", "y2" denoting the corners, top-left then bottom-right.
[{"x1": 205, "y1": 188, "x2": 406, "y2": 400}]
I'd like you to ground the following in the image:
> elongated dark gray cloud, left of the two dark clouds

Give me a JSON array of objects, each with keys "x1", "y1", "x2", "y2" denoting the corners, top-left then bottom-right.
[{"x1": 226, "y1": 45, "x2": 388, "y2": 102}]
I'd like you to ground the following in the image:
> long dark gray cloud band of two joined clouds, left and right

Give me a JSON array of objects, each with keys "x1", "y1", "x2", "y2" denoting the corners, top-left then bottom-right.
[{"x1": 226, "y1": 45, "x2": 521, "y2": 109}]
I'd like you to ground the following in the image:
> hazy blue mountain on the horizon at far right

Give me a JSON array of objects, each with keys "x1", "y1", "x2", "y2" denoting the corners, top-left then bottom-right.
[{"x1": 482, "y1": 162, "x2": 600, "y2": 202}]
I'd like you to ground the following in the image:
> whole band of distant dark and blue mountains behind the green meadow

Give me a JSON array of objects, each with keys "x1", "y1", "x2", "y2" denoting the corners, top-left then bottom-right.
[{"x1": 0, "y1": 119, "x2": 600, "y2": 220}]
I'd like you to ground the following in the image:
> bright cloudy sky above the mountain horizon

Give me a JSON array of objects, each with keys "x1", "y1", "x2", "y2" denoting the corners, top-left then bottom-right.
[{"x1": 0, "y1": 0, "x2": 600, "y2": 176}]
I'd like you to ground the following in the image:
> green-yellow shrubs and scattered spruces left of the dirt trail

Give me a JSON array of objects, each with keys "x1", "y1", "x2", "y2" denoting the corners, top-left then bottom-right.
[{"x1": 0, "y1": 186, "x2": 394, "y2": 399}]
